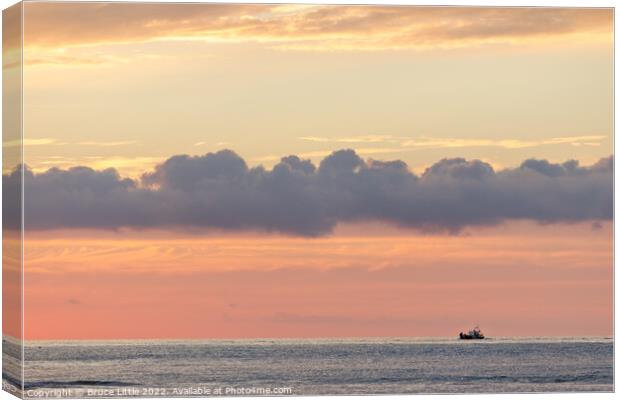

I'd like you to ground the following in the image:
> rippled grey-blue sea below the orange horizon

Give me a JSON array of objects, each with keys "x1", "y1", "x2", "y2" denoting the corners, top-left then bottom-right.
[{"x1": 3, "y1": 338, "x2": 613, "y2": 397}]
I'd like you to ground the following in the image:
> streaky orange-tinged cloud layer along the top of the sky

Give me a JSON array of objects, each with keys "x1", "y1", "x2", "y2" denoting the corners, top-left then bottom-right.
[{"x1": 25, "y1": 3, "x2": 613, "y2": 50}]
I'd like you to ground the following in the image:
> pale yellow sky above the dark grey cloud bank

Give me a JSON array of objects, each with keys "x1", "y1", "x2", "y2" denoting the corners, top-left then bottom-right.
[{"x1": 24, "y1": 3, "x2": 613, "y2": 175}]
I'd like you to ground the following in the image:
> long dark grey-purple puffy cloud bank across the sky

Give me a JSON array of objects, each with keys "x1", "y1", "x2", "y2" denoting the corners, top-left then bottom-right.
[{"x1": 3, "y1": 150, "x2": 613, "y2": 236}]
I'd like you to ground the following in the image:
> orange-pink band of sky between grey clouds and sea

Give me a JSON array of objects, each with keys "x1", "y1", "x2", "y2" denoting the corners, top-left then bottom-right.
[{"x1": 25, "y1": 223, "x2": 612, "y2": 339}]
